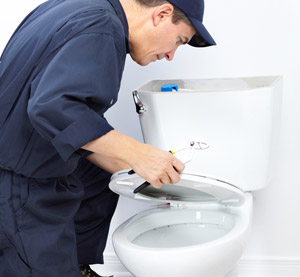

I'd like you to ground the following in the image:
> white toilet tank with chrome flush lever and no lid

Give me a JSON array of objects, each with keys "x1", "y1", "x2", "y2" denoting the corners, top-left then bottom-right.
[{"x1": 134, "y1": 76, "x2": 282, "y2": 191}]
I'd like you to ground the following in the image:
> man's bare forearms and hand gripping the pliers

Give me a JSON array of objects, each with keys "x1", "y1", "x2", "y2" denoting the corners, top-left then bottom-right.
[{"x1": 82, "y1": 130, "x2": 184, "y2": 188}]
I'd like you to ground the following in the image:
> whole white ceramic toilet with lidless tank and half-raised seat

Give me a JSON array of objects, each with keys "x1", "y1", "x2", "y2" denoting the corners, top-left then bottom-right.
[{"x1": 110, "y1": 76, "x2": 282, "y2": 277}]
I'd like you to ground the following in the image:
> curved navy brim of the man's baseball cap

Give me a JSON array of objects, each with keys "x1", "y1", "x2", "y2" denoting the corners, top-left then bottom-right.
[{"x1": 188, "y1": 17, "x2": 216, "y2": 47}]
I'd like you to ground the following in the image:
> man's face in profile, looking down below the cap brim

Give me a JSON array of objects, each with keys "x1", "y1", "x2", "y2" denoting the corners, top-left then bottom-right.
[{"x1": 130, "y1": 17, "x2": 195, "y2": 66}]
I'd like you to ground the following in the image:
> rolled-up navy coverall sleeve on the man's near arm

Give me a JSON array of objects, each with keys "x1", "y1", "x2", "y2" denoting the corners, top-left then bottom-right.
[{"x1": 27, "y1": 33, "x2": 121, "y2": 161}]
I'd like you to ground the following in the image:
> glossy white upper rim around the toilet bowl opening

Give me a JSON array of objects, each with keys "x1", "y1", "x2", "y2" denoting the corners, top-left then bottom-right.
[{"x1": 112, "y1": 194, "x2": 253, "y2": 252}]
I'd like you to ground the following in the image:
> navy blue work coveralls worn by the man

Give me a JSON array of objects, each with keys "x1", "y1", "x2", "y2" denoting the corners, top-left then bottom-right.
[{"x1": 0, "y1": 0, "x2": 129, "y2": 277}]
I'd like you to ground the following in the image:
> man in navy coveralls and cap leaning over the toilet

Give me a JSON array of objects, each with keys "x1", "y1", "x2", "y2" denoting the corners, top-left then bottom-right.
[{"x1": 0, "y1": 0, "x2": 215, "y2": 277}]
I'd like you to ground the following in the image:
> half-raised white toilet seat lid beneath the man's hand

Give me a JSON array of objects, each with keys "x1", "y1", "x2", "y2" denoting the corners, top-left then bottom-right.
[{"x1": 109, "y1": 170, "x2": 245, "y2": 206}]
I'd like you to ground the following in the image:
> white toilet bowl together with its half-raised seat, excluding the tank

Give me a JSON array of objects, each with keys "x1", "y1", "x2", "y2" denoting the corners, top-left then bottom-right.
[{"x1": 110, "y1": 171, "x2": 252, "y2": 277}]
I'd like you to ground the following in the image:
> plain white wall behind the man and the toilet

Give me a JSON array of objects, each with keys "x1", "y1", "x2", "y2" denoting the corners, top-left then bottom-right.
[{"x1": 0, "y1": 0, "x2": 300, "y2": 272}]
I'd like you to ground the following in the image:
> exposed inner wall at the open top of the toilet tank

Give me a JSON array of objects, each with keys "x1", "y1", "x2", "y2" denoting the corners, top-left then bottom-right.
[{"x1": 138, "y1": 76, "x2": 281, "y2": 93}]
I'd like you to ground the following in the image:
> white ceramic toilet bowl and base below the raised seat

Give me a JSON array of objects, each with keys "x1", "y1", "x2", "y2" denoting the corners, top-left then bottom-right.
[{"x1": 113, "y1": 194, "x2": 252, "y2": 277}]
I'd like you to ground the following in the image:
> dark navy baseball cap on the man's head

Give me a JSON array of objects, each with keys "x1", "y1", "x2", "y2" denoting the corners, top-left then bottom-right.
[{"x1": 167, "y1": 0, "x2": 216, "y2": 47}]
